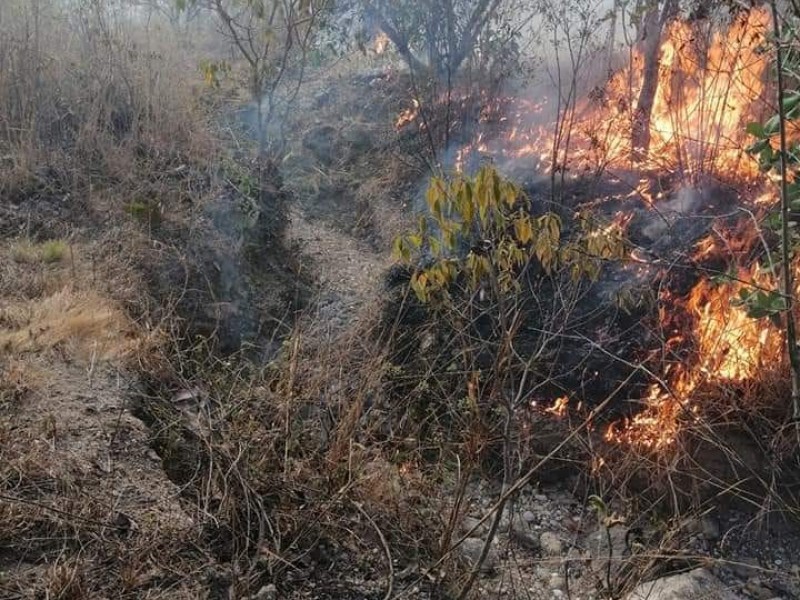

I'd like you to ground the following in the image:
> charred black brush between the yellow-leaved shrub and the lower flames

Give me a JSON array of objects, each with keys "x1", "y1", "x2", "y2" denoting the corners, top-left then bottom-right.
[{"x1": 382, "y1": 172, "x2": 757, "y2": 464}]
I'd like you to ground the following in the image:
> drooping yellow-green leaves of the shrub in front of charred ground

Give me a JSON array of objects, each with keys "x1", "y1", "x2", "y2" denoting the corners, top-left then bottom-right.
[{"x1": 394, "y1": 166, "x2": 624, "y2": 302}]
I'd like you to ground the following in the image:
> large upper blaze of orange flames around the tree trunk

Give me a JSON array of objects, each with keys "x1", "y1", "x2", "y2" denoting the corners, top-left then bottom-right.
[{"x1": 450, "y1": 9, "x2": 769, "y2": 179}]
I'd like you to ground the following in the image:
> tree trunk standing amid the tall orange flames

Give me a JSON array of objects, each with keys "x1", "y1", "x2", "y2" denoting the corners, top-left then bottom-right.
[{"x1": 631, "y1": 0, "x2": 678, "y2": 162}]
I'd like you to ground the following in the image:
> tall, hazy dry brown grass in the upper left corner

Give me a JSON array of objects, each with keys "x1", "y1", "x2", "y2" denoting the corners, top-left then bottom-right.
[{"x1": 0, "y1": 0, "x2": 215, "y2": 209}]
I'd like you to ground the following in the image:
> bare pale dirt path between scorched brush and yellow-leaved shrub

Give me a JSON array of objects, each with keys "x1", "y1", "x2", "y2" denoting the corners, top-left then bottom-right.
[{"x1": 287, "y1": 205, "x2": 391, "y2": 329}]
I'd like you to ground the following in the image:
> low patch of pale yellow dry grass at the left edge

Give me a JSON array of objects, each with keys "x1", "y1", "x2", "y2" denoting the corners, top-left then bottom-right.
[{"x1": 0, "y1": 287, "x2": 139, "y2": 361}]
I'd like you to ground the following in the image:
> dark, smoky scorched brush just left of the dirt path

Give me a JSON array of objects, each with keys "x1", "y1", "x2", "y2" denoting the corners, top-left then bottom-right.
[{"x1": 139, "y1": 157, "x2": 307, "y2": 356}]
